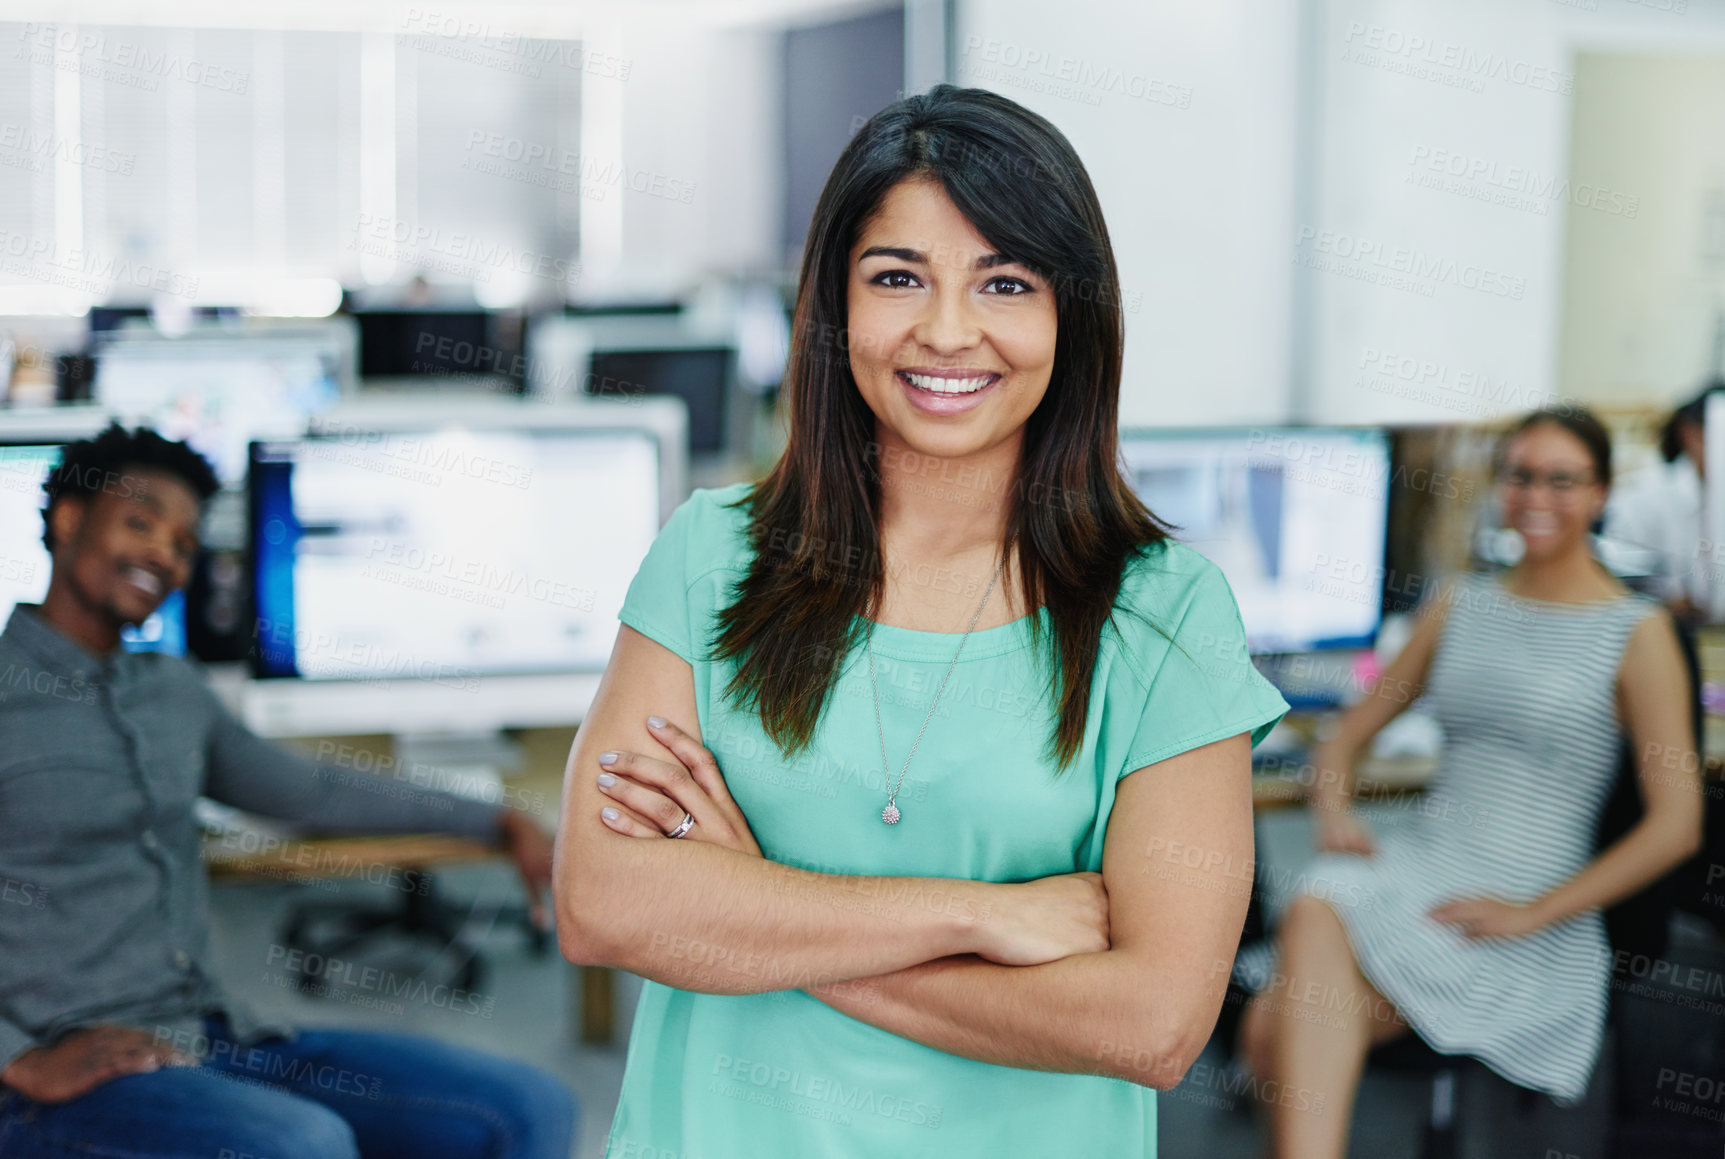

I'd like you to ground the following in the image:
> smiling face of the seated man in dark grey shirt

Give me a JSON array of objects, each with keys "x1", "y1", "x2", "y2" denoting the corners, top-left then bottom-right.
[{"x1": 50, "y1": 467, "x2": 200, "y2": 628}]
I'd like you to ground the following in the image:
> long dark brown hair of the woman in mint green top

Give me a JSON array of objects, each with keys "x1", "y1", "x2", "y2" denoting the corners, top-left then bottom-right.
[{"x1": 714, "y1": 85, "x2": 1166, "y2": 769}]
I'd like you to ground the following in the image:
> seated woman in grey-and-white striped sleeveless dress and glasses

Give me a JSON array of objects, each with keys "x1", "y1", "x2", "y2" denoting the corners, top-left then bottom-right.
[{"x1": 1240, "y1": 409, "x2": 1701, "y2": 1159}]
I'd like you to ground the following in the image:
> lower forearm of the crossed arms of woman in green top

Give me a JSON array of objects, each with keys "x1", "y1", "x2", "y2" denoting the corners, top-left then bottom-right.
[{"x1": 809, "y1": 950, "x2": 1200, "y2": 1088}]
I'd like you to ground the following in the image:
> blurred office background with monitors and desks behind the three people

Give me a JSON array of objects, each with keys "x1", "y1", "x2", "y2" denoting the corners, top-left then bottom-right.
[{"x1": 0, "y1": 0, "x2": 1725, "y2": 1157}]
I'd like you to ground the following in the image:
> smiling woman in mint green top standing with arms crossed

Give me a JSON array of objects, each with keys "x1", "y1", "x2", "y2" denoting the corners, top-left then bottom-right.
[{"x1": 557, "y1": 86, "x2": 1285, "y2": 1159}]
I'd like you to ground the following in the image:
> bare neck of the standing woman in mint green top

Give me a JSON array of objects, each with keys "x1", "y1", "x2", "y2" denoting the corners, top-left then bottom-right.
[{"x1": 876, "y1": 431, "x2": 1023, "y2": 562}]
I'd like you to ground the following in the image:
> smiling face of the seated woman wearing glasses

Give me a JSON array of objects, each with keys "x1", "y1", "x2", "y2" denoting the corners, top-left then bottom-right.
[{"x1": 1499, "y1": 423, "x2": 1606, "y2": 561}]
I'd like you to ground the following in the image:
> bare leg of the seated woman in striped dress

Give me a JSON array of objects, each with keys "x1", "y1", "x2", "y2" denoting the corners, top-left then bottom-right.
[{"x1": 1242, "y1": 895, "x2": 1408, "y2": 1159}]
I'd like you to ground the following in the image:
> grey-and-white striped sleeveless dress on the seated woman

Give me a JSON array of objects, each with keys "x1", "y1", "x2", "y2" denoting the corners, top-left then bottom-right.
[{"x1": 1295, "y1": 576, "x2": 1658, "y2": 1104}]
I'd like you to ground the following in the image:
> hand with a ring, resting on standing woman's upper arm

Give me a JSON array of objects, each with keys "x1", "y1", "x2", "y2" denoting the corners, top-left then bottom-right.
[{"x1": 599, "y1": 716, "x2": 761, "y2": 857}]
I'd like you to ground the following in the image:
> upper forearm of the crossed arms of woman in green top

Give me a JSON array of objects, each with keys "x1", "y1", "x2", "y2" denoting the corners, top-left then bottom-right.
[{"x1": 557, "y1": 833, "x2": 1009, "y2": 993}]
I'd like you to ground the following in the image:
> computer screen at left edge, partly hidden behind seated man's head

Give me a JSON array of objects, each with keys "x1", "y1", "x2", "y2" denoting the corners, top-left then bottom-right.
[{"x1": 0, "y1": 443, "x2": 186, "y2": 655}]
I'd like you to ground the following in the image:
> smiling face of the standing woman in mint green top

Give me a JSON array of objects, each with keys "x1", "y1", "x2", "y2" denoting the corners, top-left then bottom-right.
[{"x1": 849, "y1": 178, "x2": 1056, "y2": 459}]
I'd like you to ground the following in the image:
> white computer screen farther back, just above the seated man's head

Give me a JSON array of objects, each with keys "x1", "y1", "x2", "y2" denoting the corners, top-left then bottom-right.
[{"x1": 95, "y1": 335, "x2": 342, "y2": 486}]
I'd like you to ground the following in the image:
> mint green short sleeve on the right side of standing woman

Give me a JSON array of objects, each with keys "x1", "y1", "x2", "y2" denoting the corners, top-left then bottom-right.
[{"x1": 1121, "y1": 545, "x2": 1289, "y2": 776}]
